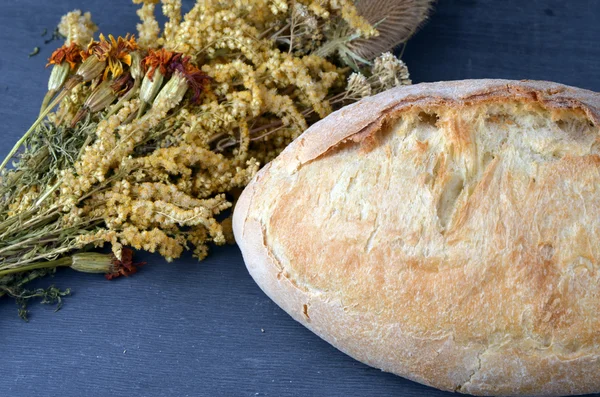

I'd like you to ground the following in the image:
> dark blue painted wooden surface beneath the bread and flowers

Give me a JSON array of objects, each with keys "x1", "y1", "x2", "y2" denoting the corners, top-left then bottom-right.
[{"x1": 0, "y1": 0, "x2": 600, "y2": 397}]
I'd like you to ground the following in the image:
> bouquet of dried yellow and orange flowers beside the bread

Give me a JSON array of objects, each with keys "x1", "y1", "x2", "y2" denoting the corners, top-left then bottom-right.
[{"x1": 0, "y1": 0, "x2": 431, "y2": 316}]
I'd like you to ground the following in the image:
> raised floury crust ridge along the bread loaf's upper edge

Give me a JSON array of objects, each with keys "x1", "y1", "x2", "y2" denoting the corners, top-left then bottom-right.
[{"x1": 278, "y1": 79, "x2": 600, "y2": 168}]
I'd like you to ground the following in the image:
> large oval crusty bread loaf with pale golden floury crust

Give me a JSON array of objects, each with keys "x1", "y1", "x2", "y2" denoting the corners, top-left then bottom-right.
[{"x1": 234, "y1": 80, "x2": 600, "y2": 396}]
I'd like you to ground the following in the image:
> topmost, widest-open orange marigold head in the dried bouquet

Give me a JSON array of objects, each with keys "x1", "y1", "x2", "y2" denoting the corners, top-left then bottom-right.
[{"x1": 81, "y1": 34, "x2": 138, "y2": 80}]
